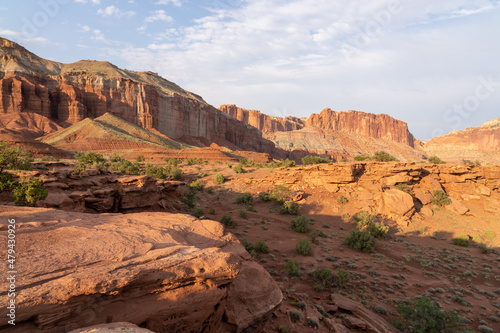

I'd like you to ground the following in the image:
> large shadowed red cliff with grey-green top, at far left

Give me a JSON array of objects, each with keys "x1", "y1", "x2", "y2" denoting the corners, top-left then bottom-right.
[{"x1": 0, "y1": 39, "x2": 274, "y2": 153}]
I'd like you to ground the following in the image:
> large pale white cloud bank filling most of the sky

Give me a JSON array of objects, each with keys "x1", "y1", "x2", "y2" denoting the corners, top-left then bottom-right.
[{"x1": 103, "y1": 0, "x2": 500, "y2": 139}]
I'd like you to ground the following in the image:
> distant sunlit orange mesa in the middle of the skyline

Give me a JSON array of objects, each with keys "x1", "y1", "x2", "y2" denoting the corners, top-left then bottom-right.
[{"x1": 220, "y1": 105, "x2": 422, "y2": 161}]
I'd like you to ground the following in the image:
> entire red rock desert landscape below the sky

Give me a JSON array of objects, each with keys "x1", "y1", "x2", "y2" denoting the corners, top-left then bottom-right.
[{"x1": 0, "y1": 38, "x2": 500, "y2": 333}]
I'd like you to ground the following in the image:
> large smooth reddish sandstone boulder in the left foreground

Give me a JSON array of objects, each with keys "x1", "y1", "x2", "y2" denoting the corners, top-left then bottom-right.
[{"x1": 0, "y1": 206, "x2": 282, "y2": 333}]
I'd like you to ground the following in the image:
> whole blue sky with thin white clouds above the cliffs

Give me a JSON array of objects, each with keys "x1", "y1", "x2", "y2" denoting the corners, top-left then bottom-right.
[{"x1": 0, "y1": 0, "x2": 500, "y2": 140}]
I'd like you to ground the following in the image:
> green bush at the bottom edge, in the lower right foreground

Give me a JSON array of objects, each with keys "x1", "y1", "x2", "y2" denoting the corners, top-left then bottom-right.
[{"x1": 393, "y1": 296, "x2": 472, "y2": 333}]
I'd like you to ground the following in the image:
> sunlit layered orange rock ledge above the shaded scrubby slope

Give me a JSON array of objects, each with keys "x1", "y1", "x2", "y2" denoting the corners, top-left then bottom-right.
[{"x1": 264, "y1": 162, "x2": 500, "y2": 223}]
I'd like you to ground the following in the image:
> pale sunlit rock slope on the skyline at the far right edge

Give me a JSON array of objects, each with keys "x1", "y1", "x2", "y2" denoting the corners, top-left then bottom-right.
[{"x1": 424, "y1": 118, "x2": 500, "y2": 164}]
